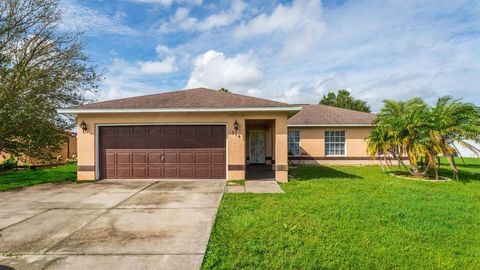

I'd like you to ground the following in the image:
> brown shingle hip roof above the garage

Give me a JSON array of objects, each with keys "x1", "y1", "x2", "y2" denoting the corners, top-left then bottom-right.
[{"x1": 63, "y1": 88, "x2": 291, "y2": 110}]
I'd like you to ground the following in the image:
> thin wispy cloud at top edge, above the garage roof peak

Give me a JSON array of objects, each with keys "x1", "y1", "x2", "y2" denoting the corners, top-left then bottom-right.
[{"x1": 160, "y1": 0, "x2": 247, "y2": 33}]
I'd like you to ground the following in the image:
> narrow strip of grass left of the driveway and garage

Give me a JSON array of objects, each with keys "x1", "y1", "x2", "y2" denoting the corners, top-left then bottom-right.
[{"x1": 0, "y1": 164, "x2": 77, "y2": 191}]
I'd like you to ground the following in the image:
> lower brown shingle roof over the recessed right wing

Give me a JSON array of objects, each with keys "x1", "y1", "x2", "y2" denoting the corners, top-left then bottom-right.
[{"x1": 288, "y1": 105, "x2": 376, "y2": 126}]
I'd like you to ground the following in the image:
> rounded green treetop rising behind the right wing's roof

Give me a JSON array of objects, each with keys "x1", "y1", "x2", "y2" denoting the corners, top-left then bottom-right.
[{"x1": 319, "y1": 89, "x2": 371, "y2": 112}]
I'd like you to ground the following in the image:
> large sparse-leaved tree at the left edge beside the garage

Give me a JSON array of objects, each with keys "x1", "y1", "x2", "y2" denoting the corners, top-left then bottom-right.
[{"x1": 0, "y1": 0, "x2": 99, "y2": 159}]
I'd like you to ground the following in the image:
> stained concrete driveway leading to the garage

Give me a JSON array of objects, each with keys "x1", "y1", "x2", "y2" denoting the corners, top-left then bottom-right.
[{"x1": 0, "y1": 180, "x2": 225, "y2": 269}]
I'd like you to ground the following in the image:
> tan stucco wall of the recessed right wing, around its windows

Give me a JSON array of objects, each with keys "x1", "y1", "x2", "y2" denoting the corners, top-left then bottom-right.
[{"x1": 288, "y1": 127, "x2": 376, "y2": 165}]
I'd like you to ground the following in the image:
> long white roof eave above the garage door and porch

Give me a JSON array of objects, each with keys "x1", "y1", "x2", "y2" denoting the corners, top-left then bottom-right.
[{"x1": 57, "y1": 107, "x2": 302, "y2": 114}]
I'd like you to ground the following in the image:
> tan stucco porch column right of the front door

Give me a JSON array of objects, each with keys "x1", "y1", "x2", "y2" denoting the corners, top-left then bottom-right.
[{"x1": 275, "y1": 116, "x2": 288, "y2": 182}]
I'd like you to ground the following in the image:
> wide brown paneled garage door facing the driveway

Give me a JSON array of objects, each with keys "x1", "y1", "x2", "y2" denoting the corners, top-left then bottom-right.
[{"x1": 99, "y1": 125, "x2": 226, "y2": 179}]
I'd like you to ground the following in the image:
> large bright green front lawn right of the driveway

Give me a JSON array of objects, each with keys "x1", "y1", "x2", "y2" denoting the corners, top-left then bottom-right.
[{"x1": 203, "y1": 159, "x2": 480, "y2": 269}]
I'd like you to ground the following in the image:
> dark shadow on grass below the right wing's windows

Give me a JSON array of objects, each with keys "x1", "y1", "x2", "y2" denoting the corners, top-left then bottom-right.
[{"x1": 290, "y1": 166, "x2": 363, "y2": 181}]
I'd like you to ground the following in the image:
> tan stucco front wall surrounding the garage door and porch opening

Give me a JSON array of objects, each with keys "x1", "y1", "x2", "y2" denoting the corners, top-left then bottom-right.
[{"x1": 77, "y1": 112, "x2": 288, "y2": 181}]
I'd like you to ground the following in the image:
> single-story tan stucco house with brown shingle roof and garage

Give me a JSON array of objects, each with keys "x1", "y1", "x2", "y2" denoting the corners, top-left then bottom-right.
[{"x1": 59, "y1": 88, "x2": 375, "y2": 181}]
